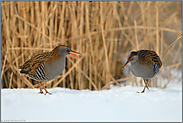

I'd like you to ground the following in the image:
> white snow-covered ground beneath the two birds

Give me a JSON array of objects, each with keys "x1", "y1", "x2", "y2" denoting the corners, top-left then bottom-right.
[{"x1": 1, "y1": 82, "x2": 182, "y2": 122}]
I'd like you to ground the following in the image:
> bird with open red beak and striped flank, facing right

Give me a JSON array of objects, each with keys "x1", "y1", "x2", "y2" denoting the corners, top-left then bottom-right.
[{"x1": 20, "y1": 45, "x2": 82, "y2": 95}]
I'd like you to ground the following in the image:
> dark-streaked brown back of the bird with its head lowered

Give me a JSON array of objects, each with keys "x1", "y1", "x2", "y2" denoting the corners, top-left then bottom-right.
[{"x1": 137, "y1": 50, "x2": 162, "y2": 68}]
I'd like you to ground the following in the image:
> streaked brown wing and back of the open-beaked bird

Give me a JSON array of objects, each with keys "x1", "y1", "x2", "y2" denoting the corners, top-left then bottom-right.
[{"x1": 20, "y1": 52, "x2": 50, "y2": 75}]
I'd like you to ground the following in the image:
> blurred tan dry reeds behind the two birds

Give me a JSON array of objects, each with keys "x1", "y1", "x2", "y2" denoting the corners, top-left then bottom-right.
[{"x1": 1, "y1": 1, "x2": 182, "y2": 90}]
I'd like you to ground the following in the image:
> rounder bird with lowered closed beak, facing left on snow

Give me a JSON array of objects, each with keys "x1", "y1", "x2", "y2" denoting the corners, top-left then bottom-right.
[{"x1": 122, "y1": 50, "x2": 162, "y2": 93}]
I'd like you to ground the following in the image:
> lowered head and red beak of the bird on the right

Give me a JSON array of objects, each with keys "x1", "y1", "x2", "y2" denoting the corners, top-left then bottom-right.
[{"x1": 123, "y1": 51, "x2": 138, "y2": 68}]
